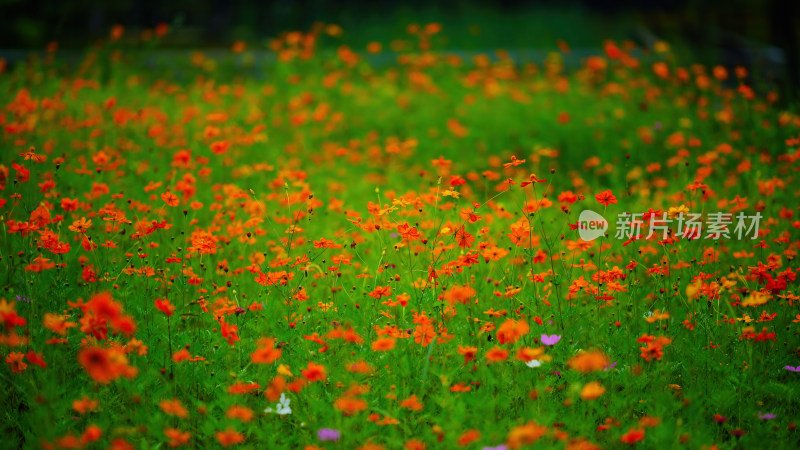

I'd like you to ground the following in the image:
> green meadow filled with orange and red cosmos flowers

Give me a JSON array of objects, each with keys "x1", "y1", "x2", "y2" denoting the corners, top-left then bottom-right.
[{"x1": 0, "y1": 23, "x2": 800, "y2": 450}]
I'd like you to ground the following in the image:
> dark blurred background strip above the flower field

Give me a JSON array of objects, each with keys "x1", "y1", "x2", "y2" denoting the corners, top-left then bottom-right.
[{"x1": 0, "y1": 0, "x2": 800, "y2": 94}]
